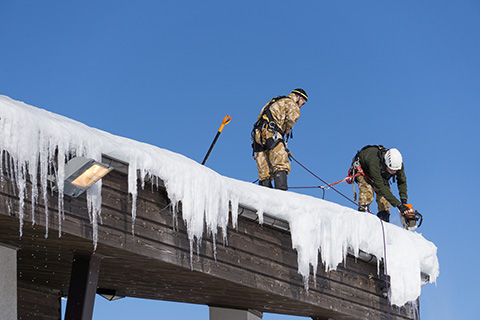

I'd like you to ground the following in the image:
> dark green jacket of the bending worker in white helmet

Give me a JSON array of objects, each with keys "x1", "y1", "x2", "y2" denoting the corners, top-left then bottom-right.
[{"x1": 359, "y1": 146, "x2": 408, "y2": 207}]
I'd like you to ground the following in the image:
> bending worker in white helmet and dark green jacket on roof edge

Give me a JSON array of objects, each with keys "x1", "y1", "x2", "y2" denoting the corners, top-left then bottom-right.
[{"x1": 352, "y1": 145, "x2": 413, "y2": 222}]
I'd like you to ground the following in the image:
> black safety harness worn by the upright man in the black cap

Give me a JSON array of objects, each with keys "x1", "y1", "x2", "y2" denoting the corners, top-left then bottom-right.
[{"x1": 251, "y1": 96, "x2": 292, "y2": 153}]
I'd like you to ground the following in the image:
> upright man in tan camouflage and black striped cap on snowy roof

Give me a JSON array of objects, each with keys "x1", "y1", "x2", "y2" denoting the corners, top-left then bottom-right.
[{"x1": 252, "y1": 89, "x2": 308, "y2": 190}]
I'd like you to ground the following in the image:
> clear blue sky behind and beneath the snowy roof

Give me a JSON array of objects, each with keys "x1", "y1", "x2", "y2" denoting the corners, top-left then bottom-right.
[{"x1": 0, "y1": 0, "x2": 480, "y2": 320}]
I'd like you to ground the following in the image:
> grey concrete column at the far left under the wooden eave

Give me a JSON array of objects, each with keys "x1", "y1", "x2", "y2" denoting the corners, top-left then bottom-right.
[{"x1": 0, "y1": 244, "x2": 17, "y2": 320}]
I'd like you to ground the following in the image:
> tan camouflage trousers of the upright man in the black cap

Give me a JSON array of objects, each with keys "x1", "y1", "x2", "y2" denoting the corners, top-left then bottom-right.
[{"x1": 255, "y1": 142, "x2": 290, "y2": 180}]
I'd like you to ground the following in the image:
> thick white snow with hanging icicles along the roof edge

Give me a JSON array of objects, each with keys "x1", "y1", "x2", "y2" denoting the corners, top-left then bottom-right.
[{"x1": 0, "y1": 95, "x2": 439, "y2": 306}]
